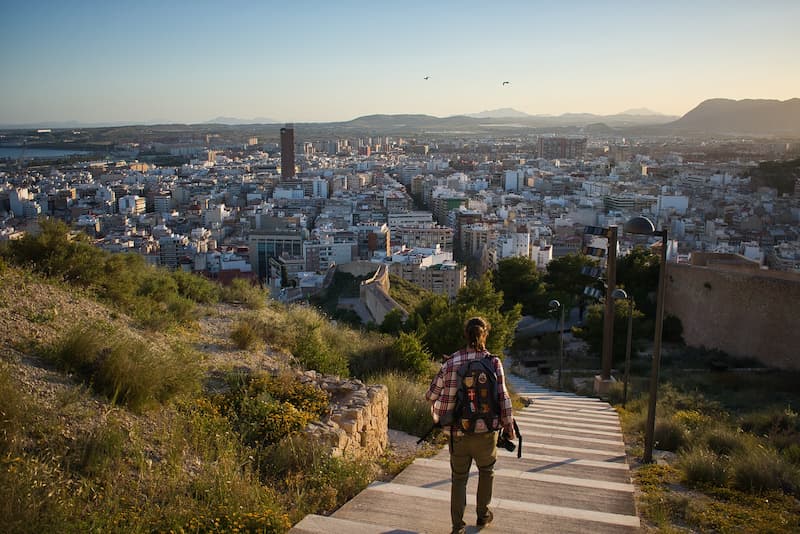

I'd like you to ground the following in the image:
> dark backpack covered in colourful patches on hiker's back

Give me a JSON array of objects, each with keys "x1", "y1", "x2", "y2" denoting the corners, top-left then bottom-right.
[{"x1": 442, "y1": 354, "x2": 500, "y2": 434}]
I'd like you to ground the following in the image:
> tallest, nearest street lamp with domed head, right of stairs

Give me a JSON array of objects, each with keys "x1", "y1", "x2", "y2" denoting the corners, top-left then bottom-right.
[{"x1": 624, "y1": 216, "x2": 667, "y2": 463}]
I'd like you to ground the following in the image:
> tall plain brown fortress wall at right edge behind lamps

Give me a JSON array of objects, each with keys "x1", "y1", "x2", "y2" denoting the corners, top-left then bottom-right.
[{"x1": 665, "y1": 263, "x2": 800, "y2": 369}]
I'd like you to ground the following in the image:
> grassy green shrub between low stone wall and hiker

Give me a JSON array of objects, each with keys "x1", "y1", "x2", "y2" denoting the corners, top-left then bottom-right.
[{"x1": 369, "y1": 371, "x2": 433, "y2": 436}]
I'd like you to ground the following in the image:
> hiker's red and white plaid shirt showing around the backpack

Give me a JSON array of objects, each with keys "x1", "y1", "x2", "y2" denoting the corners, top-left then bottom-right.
[{"x1": 425, "y1": 350, "x2": 514, "y2": 432}]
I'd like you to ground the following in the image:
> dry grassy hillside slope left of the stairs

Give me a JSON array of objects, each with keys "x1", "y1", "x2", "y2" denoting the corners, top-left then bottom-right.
[{"x1": 0, "y1": 261, "x2": 413, "y2": 532}]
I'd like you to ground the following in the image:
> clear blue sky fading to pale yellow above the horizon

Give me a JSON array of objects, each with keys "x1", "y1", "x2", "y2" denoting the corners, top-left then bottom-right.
[{"x1": 0, "y1": 0, "x2": 800, "y2": 124}]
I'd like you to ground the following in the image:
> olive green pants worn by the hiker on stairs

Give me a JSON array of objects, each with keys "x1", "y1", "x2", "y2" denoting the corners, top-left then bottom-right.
[{"x1": 450, "y1": 432, "x2": 497, "y2": 530}]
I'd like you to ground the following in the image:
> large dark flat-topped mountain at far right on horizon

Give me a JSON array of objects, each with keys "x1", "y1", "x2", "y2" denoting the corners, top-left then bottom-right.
[{"x1": 664, "y1": 98, "x2": 800, "y2": 135}]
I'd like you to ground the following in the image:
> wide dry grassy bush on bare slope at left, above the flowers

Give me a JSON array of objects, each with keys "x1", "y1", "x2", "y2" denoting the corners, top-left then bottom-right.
[{"x1": 46, "y1": 325, "x2": 200, "y2": 410}]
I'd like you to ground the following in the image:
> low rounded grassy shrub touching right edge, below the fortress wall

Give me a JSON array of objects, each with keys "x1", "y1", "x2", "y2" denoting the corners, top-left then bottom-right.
[{"x1": 731, "y1": 447, "x2": 800, "y2": 494}]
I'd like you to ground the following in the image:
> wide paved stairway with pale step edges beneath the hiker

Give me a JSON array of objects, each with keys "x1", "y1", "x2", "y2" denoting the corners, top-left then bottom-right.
[{"x1": 290, "y1": 375, "x2": 640, "y2": 534}]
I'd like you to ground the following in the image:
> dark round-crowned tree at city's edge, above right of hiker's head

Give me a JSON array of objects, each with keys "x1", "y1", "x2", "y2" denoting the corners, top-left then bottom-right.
[{"x1": 492, "y1": 257, "x2": 546, "y2": 315}]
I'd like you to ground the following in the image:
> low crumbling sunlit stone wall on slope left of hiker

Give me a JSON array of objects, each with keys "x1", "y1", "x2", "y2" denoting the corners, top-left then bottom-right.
[{"x1": 300, "y1": 371, "x2": 389, "y2": 458}]
